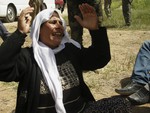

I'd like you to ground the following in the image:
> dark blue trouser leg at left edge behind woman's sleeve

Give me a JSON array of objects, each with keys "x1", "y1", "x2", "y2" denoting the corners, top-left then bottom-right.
[{"x1": 0, "y1": 20, "x2": 10, "y2": 40}]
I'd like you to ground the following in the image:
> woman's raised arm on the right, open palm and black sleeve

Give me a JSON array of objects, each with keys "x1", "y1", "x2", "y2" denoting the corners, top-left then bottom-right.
[{"x1": 75, "y1": 3, "x2": 110, "y2": 70}]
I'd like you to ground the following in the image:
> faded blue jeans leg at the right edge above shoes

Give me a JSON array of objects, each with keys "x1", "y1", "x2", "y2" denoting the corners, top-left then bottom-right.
[{"x1": 131, "y1": 40, "x2": 150, "y2": 85}]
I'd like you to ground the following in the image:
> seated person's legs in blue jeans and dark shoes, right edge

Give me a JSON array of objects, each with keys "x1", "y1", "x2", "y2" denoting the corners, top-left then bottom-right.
[{"x1": 115, "y1": 41, "x2": 150, "y2": 105}]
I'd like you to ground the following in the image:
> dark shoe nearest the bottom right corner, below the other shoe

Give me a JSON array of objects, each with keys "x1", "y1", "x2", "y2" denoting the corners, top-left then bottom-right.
[{"x1": 128, "y1": 87, "x2": 150, "y2": 105}]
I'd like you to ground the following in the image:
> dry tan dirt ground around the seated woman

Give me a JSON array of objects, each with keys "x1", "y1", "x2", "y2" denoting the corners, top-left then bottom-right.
[{"x1": 0, "y1": 10, "x2": 150, "y2": 113}]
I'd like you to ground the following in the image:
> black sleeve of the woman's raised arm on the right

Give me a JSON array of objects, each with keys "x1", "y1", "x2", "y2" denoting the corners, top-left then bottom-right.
[{"x1": 80, "y1": 27, "x2": 111, "y2": 70}]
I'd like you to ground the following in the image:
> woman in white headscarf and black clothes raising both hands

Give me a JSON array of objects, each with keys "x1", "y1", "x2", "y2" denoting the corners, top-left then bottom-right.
[{"x1": 0, "y1": 4, "x2": 130, "y2": 113}]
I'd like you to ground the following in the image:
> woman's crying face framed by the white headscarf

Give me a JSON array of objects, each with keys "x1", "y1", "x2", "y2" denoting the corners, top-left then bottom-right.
[{"x1": 40, "y1": 12, "x2": 64, "y2": 49}]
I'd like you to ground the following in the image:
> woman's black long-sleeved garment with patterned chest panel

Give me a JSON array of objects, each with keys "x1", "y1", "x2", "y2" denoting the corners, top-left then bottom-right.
[{"x1": 0, "y1": 27, "x2": 110, "y2": 113}]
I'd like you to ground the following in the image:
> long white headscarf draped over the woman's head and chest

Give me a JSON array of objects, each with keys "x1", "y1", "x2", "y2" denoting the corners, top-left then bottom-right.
[{"x1": 30, "y1": 9, "x2": 80, "y2": 113}]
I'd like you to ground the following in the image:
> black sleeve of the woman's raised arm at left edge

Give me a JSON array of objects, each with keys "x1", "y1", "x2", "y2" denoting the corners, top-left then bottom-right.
[{"x1": 0, "y1": 30, "x2": 26, "y2": 81}]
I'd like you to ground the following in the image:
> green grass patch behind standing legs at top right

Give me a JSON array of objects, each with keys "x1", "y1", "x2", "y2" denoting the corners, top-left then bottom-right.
[{"x1": 103, "y1": 0, "x2": 150, "y2": 30}]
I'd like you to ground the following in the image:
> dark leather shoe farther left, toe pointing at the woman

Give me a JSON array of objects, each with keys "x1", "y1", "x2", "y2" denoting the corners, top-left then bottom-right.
[{"x1": 115, "y1": 81, "x2": 144, "y2": 95}]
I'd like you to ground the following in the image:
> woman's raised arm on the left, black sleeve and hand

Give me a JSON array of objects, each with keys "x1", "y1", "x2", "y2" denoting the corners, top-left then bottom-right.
[{"x1": 0, "y1": 7, "x2": 33, "y2": 81}]
